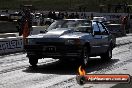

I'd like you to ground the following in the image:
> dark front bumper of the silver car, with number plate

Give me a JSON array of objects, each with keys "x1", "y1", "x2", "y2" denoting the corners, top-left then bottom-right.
[{"x1": 24, "y1": 45, "x2": 83, "y2": 58}]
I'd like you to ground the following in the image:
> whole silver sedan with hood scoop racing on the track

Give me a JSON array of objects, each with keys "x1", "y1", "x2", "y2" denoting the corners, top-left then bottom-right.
[{"x1": 25, "y1": 19, "x2": 116, "y2": 66}]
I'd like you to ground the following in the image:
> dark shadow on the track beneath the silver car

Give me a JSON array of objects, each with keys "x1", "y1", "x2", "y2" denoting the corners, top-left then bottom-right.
[{"x1": 23, "y1": 58, "x2": 119, "y2": 75}]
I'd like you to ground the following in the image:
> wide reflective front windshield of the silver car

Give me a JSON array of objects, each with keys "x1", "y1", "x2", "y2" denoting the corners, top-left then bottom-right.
[{"x1": 47, "y1": 20, "x2": 91, "y2": 32}]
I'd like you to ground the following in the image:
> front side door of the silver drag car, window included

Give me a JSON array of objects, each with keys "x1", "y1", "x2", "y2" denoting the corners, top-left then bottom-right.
[{"x1": 90, "y1": 22, "x2": 103, "y2": 55}]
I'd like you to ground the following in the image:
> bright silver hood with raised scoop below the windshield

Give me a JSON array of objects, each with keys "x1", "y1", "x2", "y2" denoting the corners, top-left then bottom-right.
[{"x1": 28, "y1": 28, "x2": 89, "y2": 38}]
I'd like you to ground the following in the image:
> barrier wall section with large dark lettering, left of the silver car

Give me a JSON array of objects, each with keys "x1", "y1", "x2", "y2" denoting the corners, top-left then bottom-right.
[{"x1": 0, "y1": 37, "x2": 23, "y2": 55}]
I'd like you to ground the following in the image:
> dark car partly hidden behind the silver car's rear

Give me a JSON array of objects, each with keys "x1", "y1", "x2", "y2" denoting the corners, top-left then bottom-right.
[{"x1": 107, "y1": 24, "x2": 126, "y2": 37}]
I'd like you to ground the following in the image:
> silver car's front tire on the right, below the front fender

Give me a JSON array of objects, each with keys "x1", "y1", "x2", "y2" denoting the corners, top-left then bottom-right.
[{"x1": 80, "y1": 47, "x2": 89, "y2": 66}]
